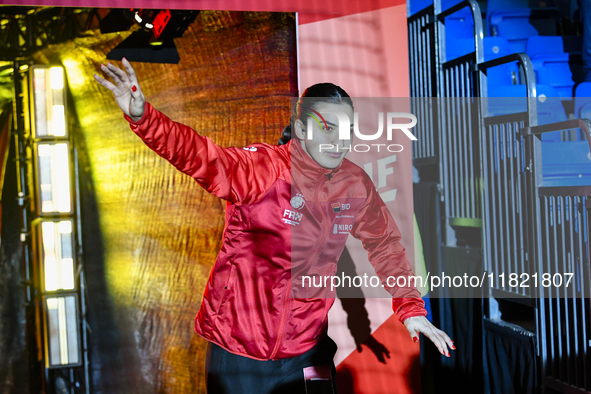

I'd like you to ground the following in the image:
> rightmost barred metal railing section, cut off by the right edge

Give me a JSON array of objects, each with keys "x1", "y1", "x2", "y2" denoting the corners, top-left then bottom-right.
[{"x1": 521, "y1": 119, "x2": 591, "y2": 392}]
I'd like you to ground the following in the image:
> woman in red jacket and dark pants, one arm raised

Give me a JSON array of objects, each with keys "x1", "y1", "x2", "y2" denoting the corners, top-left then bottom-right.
[{"x1": 95, "y1": 59, "x2": 454, "y2": 393}]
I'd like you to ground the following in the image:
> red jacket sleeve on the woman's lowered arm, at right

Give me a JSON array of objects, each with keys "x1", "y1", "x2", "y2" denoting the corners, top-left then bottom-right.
[{"x1": 351, "y1": 178, "x2": 427, "y2": 322}]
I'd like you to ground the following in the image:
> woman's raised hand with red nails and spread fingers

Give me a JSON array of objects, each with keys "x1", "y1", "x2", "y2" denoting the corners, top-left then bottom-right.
[{"x1": 94, "y1": 58, "x2": 146, "y2": 121}]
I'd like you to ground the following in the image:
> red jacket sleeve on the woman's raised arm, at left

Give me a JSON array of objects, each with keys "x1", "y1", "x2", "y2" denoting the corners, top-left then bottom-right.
[{"x1": 125, "y1": 103, "x2": 289, "y2": 204}]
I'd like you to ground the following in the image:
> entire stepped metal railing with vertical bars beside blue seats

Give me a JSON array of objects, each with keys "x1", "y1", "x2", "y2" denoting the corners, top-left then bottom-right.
[{"x1": 409, "y1": 0, "x2": 591, "y2": 392}]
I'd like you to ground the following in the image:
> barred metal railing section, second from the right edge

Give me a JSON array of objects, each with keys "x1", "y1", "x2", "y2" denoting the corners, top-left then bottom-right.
[{"x1": 478, "y1": 53, "x2": 537, "y2": 298}]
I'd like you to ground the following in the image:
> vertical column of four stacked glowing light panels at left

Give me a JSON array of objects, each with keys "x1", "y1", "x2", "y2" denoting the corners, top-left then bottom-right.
[{"x1": 25, "y1": 65, "x2": 89, "y2": 386}]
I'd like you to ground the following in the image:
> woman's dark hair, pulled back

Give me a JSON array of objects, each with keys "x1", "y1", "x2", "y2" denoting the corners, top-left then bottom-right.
[{"x1": 278, "y1": 82, "x2": 353, "y2": 145}]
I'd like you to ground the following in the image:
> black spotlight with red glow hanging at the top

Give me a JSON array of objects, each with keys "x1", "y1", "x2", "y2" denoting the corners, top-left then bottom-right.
[{"x1": 101, "y1": 9, "x2": 199, "y2": 64}]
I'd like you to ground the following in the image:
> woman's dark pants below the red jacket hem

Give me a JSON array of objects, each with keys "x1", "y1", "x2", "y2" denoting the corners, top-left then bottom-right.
[{"x1": 205, "y1": 336, "x2": 337, "y2": 394}]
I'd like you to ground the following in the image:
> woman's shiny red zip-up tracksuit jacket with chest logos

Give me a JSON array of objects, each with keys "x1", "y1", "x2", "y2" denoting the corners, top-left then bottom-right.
[{"x1": 126, "y1": 103, "x2": 426, "y2": 360}]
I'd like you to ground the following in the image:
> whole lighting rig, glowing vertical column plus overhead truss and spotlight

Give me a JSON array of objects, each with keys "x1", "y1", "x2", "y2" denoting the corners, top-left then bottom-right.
[{"x1": 0, "y1": 6, "x2": 198, "y2": 394}]
